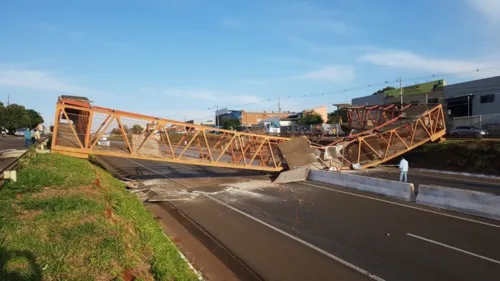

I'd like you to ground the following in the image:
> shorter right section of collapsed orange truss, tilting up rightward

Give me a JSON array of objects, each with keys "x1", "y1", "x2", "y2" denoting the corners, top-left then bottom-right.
[{"x1": 335, "y1": 105, "x2": 446, "y2": 169}]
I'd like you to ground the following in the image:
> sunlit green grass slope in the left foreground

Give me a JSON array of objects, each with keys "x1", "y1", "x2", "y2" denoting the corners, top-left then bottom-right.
[{"x1": 0, "y1": 154, "x2": 197, "y2": 280}]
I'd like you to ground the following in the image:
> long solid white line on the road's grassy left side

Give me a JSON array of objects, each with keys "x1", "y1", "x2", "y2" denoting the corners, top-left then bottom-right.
[{"x1": 124, "y1": 158, "x2": 385, "y2": 281}]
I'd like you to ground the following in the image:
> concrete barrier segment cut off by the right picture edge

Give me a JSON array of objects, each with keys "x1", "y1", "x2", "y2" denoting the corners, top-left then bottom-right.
[{"x1": 416, "y1": 184, "x2": 500, "y2": 220}]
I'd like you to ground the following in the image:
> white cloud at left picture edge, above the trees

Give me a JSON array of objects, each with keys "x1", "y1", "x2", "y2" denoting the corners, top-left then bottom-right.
[{"x1": 0, "y1": 69, "x2": 111, "y2": 97}]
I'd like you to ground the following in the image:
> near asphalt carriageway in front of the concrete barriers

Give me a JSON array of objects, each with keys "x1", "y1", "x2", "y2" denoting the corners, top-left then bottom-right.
[{"x1": 97, "y1": 155, "x2": 500, "y2": 281}]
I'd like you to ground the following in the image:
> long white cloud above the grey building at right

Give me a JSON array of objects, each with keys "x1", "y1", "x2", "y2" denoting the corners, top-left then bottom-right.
[{"x1": 358, "y1": 51, "x2": 494, "y2": 74}]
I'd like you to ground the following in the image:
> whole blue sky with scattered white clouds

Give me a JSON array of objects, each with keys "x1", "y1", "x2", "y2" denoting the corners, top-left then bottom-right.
[{"x1": 0, "y1": 0, "x2": 500, "y2": 124}]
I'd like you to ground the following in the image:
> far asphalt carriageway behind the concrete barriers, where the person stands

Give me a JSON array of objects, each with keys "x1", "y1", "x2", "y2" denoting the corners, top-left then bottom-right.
[{"x1": 359, "y1": 168, "x2": 500, "y2": 195}]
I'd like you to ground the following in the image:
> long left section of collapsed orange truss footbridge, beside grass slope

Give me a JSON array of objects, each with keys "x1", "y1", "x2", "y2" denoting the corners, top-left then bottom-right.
[{"x1": 51, "y1": 97, "x2": 289, "y2": 171}]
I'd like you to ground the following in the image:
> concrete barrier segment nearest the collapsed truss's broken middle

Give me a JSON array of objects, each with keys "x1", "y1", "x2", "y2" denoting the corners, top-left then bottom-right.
[{"x1": 307, "y1": 170, "x2": 415, "y2": 201}]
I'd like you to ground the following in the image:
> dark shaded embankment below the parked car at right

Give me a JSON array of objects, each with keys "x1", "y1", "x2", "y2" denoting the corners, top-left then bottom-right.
[{"x1": 395, "y1": 140, "x2": 500, "y2": 175}]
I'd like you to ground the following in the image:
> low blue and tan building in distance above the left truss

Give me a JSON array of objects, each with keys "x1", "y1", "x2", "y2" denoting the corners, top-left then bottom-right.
[{"x1": 215, "y1": 108, "x2": 291, "y2": 127}]
